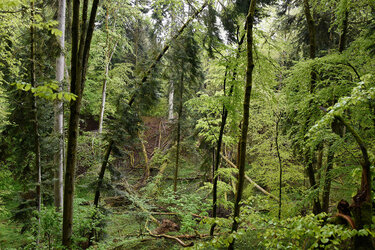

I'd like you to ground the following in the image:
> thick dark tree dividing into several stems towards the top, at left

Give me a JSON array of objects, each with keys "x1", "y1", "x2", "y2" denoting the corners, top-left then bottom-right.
[{"x1": 62, "y1": 0, "x2": 99, "y2": 248}]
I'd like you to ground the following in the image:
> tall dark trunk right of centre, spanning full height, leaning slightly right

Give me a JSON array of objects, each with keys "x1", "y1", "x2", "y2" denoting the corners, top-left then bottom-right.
[{"x1": 229, "y1": 0, "x2": 256, "y2": 249}]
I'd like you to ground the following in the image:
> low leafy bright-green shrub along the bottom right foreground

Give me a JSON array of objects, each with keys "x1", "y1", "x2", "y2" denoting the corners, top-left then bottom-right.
[{"x1": 195, "y1": 212, "x2": 362, "y2": 249}]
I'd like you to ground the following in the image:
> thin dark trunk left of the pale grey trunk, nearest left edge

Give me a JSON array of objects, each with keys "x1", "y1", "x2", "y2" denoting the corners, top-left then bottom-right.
[{"x1": 30, "y1": 1, "x2": 42, "y2": 244}]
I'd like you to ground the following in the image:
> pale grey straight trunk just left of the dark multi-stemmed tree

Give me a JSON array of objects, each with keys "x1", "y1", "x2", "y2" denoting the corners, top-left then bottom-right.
[{"x1": 54, "y1": 0, "x2": 66, "y2": 211}]
